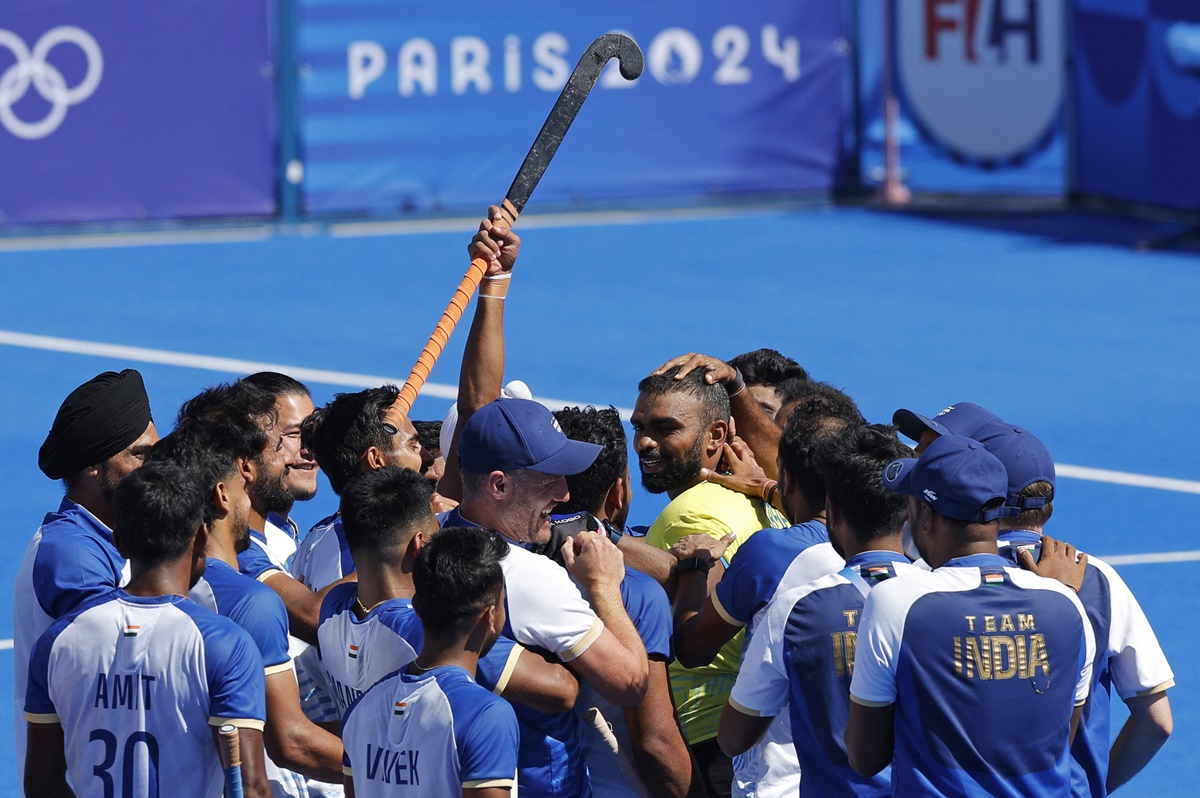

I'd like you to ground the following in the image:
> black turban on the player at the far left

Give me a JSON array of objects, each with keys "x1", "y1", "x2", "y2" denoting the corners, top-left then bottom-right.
[{"x1": 37, "y1": 368, "x2": 150, "y2": 479}]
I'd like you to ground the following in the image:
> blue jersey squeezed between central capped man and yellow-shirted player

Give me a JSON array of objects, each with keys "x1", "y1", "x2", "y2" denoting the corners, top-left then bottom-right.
[{"x1": 575, "y1": 565, "x2": 673, "y2": 798}]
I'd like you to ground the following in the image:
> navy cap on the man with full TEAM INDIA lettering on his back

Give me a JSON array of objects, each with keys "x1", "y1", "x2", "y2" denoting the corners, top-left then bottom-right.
[{"x1": 883, "y1": 434, "x2": 1016, "y2": 523}]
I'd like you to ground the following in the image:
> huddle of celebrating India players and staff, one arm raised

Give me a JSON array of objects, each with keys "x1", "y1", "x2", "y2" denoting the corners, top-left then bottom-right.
[{"x1": 13, "y1": 209, "x2": 1174, "y2": 798}]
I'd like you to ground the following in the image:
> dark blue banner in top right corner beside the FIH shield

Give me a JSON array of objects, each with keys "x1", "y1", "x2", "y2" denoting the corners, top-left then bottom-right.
[{"x1": 1074, "y1": 0, "x2": 1200, "y2": 210}]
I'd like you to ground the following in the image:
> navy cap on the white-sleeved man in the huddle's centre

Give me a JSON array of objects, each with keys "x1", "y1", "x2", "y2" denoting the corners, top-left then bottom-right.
[{"x1": 458, "y1": 398, "x2": 602, "y2": 476}]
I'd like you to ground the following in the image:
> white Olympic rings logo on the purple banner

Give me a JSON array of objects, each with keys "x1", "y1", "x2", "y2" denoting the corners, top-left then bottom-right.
[{"x1": 0, "y1": 25, "x2": 104, "y2": 140}]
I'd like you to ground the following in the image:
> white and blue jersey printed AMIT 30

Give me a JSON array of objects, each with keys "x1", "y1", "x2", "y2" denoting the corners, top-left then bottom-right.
[{"x1": 25, "y1": 589, "x2": 266, "y2": 798}]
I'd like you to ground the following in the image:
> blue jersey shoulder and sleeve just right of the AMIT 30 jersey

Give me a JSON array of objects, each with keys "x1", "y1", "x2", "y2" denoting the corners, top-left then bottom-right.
[{"x1": 187, "y1": 557, "x2": 292, "y2": 676}]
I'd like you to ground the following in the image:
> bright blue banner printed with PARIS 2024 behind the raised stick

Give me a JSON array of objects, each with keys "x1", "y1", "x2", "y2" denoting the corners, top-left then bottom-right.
[{"x1": 298, "y1": 0, "x2": 851, "y2": 214}]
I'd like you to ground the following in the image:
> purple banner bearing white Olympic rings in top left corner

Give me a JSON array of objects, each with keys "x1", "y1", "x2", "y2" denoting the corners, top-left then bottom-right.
[{"x1": 0, "y1": 0, "x2": 276, "y2": 223}]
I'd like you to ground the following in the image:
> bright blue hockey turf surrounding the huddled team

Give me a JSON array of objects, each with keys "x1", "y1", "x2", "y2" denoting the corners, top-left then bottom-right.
[{"x1": 0, "y1": 206, "x2": 1200, "y2": 797}]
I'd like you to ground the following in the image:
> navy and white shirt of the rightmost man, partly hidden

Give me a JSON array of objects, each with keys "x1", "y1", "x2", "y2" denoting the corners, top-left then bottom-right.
[{"x1": 1000, "y1": 530, "x2": 1175, "y2": 798}]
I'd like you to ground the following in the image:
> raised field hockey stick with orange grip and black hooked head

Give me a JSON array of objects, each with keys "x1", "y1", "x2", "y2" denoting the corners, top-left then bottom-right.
[{"x1": 384, "y1": 34, "x2": 642, "y2": 430}]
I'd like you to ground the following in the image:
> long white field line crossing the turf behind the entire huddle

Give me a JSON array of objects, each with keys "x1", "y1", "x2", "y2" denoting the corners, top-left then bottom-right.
[{"x1": 0, "y1": 330, "x2": 1200, "y2": 494}]
